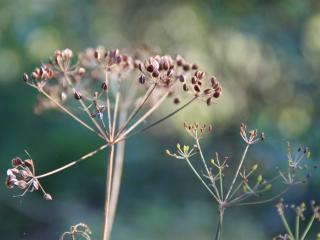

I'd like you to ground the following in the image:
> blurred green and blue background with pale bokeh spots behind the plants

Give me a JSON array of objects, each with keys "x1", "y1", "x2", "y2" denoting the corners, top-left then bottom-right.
[{"x1": 0, "y1": 0, "x2": 320, "y2": 240}]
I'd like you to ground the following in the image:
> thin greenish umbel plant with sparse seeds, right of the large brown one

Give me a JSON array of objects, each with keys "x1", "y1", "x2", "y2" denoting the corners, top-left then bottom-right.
[{"x1": 166, "y1": 123, "x2": 310, "y2": 239}]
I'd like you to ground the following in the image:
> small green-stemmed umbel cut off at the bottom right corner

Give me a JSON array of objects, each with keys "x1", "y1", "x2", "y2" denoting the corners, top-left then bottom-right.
[{"x1": 273, "y1": 199, "x2": 320, "y2": 240}]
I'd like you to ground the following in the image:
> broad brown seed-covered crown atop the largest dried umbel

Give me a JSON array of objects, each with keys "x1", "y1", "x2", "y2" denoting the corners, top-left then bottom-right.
[{"x1": 23, "y1": 48, "x2": 222, "y2": 113}]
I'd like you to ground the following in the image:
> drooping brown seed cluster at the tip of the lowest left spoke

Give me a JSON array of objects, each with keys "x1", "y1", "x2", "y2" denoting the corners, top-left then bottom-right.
[{"x1": 6, "y1": 157, "x2": 52, "y2": 200}]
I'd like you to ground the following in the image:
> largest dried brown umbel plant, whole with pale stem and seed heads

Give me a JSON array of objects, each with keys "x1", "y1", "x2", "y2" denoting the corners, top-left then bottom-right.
[{"x1": 6, "y1": 48, "x2": 222, "y2": 240}]
